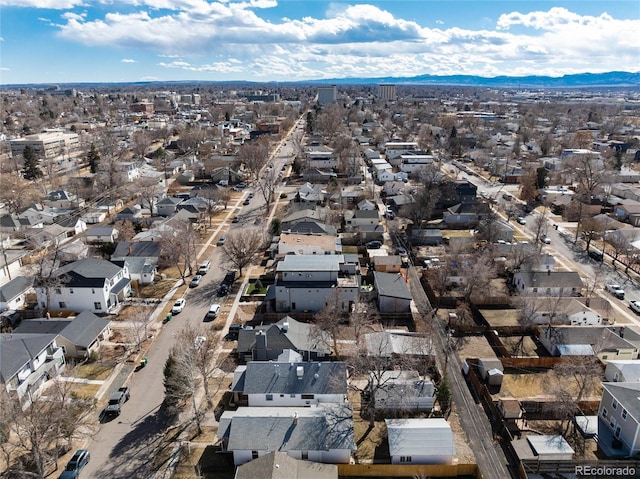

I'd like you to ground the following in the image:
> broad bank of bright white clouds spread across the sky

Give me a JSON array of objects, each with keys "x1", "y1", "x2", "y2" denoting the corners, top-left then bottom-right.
[{"x1": 40, "y1": 0, "x2": 640, "y2": 79}]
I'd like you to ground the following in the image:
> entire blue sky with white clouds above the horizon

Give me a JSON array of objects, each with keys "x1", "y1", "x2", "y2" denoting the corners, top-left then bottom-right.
[{"x1": 0, "y1": 0, "x2": 640, "y2": 84}]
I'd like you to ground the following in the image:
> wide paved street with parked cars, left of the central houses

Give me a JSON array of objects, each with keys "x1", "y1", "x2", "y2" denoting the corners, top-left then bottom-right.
[{"x1": 82, "y1": 117, "x2": 308, "y2": 479}]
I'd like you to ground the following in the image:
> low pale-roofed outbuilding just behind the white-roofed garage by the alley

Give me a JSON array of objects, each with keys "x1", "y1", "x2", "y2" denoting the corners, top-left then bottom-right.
[{"x1": 369, "y1": 370, "x2": 436, "y2": 414}]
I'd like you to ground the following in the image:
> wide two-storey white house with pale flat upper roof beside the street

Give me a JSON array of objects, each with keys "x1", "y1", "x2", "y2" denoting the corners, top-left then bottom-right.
[{"x1": 272, "y1": 255, "x2": 360, "y2": 312}]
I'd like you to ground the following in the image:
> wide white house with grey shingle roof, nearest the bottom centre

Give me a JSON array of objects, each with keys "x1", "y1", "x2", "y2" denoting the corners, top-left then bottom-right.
[{"x1": 217, "y1": 402, "x2": 356, "y2": 466}]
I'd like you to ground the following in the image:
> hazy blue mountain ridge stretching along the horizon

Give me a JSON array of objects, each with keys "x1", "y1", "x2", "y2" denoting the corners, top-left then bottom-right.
[{"x1": 0, "y1": 71, "x2": 640, "y2": 88}]
